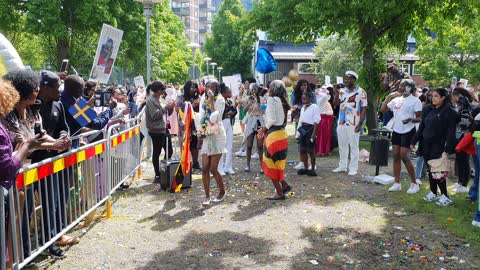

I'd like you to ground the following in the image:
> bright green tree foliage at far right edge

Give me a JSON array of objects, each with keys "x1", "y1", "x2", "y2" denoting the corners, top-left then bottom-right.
[{"x1": 415, "y1": 7, "x2": 480, "y2": 87}]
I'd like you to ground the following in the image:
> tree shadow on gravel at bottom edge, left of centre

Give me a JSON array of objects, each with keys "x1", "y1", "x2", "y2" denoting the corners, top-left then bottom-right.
[{"x1": 138, "y1": 231, "x2": 278, "y2": 270}]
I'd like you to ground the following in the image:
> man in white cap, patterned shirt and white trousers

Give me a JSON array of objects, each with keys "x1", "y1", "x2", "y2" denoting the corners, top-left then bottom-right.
[{"x1": 332, "y1": 71, "x2": 368, "y2": 176}]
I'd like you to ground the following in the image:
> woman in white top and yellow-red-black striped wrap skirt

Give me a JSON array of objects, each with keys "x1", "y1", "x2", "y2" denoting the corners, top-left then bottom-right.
[{"x1": 257, "y1": 80, "x2": 291, "y2": 200}]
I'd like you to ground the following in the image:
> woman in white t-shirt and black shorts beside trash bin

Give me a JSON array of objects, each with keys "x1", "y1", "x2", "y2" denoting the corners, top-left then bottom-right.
[{"x1": 381, "y1": 79, "x2": 422, "y2": 194}]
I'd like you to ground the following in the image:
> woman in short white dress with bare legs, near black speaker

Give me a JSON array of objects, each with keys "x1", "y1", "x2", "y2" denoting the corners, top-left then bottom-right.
[{"x1": 200, "y1": 81, "x2": 227, "y2": 205}]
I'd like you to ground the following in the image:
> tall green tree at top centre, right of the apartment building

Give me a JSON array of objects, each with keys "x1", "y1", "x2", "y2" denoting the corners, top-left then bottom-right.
[{"x1": 204, "y1": 0, "x2": 253, "y2": 78}]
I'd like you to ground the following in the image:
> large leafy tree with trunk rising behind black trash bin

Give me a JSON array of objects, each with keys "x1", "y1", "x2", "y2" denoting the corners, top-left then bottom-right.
[{"x1": 246, "y1": 0, "x2": 459, "y2": 130}]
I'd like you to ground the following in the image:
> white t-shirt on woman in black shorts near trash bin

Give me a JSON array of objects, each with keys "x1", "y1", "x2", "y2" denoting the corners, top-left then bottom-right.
[{"x1": 387, "y1": 95, "x2": 422, "y2": 134}]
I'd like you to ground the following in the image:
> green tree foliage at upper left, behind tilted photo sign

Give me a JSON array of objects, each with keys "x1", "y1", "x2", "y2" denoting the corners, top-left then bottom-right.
[{"x1": 0, "y1": 0, "x2": 193, "y2": 82}]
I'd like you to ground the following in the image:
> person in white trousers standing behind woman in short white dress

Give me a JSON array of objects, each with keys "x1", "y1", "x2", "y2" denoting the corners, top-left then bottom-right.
[{"x1": 218, "y1": 83, "x2": 237, "y2": 176}]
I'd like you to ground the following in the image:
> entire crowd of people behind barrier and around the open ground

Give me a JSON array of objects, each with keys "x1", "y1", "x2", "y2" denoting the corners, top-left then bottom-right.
[{"x1": 0, "y1": 63, "x2": 480, "y2": 266}]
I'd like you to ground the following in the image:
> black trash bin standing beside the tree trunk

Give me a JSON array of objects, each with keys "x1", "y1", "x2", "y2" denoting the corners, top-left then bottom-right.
[{"x1": 368, "y1": 129, "x2": 391, "y2": 175}]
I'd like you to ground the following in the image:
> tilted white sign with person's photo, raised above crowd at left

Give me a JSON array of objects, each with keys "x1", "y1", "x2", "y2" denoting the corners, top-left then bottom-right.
[{"x1": 90, "y1": 24, "x2": 123, "y2": 83}]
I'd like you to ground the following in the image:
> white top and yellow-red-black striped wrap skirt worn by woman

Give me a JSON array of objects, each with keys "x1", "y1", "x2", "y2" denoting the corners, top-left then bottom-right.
[{"x1": 262, "y1": 97, "x2": 288, "y2": 181}]
